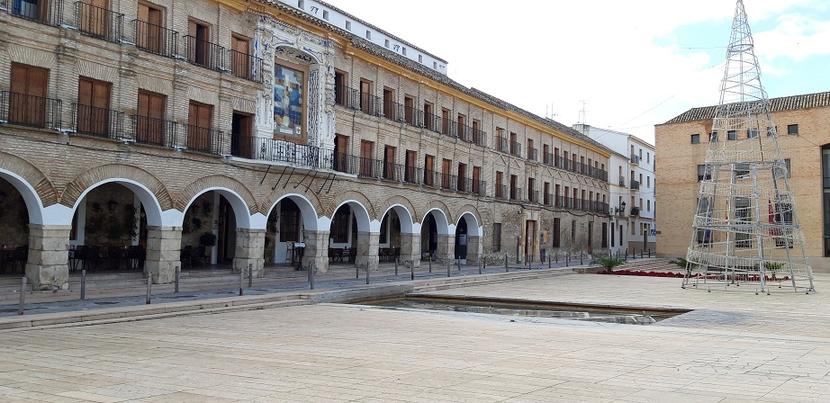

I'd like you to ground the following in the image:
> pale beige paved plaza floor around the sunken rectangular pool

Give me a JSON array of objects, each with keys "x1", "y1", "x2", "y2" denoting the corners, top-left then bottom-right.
[{"x1": 0, "y1": 274, "x2": 830, "y2": 402}]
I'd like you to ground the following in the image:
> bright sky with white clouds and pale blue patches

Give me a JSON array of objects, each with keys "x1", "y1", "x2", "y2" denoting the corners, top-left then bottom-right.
[{"x1": 330, "y1": 0, "x2": 830, "y2": 142}]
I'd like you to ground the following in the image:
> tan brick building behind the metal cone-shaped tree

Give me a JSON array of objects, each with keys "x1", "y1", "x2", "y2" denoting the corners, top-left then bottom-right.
[{"x1": 655, "y1": 92, "x2": 830, "y2": 270}]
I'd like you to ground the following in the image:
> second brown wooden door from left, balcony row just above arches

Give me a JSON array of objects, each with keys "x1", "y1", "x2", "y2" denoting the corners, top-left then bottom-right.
[{"x1": 76, "y1": 77, "x2": 112, "y2": 135}]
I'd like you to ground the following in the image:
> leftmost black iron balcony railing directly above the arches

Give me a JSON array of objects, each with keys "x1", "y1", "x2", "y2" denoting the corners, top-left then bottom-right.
[{"x1": 0, "y1": 91, "x2": 63, "y2": 130}]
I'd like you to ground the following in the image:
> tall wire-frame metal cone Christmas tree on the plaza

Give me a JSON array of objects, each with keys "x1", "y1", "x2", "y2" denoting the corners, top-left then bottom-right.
[{"x1": 683, "y1": 0, "x2": 814, "y2": 293}]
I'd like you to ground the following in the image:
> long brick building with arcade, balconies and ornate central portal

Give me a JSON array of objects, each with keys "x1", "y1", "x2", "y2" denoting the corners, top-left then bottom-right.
[{"x1": 0, "y1": 0, "x2": 610, "y2": 289}]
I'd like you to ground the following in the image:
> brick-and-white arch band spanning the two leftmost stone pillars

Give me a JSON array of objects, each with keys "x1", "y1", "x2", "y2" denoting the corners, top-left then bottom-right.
[{"x1": 60, "y1": 164, "x2": 175, "y2": 213}]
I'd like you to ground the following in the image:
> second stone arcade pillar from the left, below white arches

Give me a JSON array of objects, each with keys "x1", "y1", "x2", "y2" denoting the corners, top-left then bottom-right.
[{"x1": 144, "y1": 227, "x2": 182, "y2": 284}]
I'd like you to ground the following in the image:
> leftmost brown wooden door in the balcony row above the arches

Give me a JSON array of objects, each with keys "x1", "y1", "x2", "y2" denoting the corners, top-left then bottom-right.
[{"x1": 9, "y1": 63, "x2": 49, "y2": 127}]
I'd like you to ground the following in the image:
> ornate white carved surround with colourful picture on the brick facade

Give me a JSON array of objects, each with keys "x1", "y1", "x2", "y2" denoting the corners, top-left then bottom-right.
[{"x1": 254, "y1": 16, "x2": 334, "y2": 152}]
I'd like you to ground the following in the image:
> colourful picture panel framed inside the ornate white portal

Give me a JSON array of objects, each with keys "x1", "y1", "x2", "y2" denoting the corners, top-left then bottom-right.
[{"x1": 274, "y1": 64, "x2": 305, "y2": 137}]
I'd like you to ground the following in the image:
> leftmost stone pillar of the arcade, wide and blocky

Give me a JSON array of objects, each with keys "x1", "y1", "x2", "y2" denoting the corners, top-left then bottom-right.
[{"x1": 26, "y1": 224, "x2": 71, "y2": 290}]
